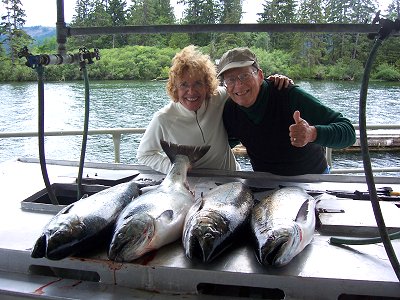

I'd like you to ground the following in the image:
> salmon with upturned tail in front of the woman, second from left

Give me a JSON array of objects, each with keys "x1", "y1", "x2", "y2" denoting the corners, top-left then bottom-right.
[{"x1": 108, "y1": 141, "x2": 210, "y2": 262}]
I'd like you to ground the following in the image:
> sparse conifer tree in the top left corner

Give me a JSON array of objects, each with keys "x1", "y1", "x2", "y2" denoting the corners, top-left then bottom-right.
[{"x1": 0, "y1": 0, "x2": 33, "y2": 64}]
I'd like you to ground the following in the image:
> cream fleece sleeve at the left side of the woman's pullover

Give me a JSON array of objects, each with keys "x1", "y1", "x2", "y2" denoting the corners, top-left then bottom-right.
[{"x1": 136, "y1": 113, "x2": 171, "y2": 174}]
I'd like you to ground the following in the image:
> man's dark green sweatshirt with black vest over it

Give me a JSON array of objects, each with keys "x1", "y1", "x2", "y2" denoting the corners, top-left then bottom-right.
[{"x1": 223, "y1": 81, "x2": 356, "y2": 175}]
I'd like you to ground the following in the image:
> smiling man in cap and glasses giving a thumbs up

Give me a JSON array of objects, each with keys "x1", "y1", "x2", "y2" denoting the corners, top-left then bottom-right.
[{"x1": 218, "y1": 48, "x2": 356, "y2": 176}]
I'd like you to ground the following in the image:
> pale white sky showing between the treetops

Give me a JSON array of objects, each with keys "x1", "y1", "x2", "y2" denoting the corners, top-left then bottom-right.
[{"x1": 13, "y1": 0, "x2": 391, "y2": 27}]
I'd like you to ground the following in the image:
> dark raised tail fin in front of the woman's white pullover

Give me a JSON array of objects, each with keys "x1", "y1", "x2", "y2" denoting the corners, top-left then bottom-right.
[{"x1": 160, "y1": 140, "x2": 211, "y2": 164}]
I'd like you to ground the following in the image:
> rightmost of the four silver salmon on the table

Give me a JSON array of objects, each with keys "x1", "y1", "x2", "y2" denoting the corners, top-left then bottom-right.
[{"x1": 250, "y1": 187, "x2": 317, "y2": 266}]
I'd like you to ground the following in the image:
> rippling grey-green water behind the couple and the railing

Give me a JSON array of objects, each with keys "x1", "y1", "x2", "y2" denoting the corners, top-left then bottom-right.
[{"x1": 0, "y1": 81, "x2": 400, "y2": 175}]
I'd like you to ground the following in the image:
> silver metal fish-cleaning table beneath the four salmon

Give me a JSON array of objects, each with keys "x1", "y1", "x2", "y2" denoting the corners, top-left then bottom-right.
[{"x1": 0, "y1": 159, "x2": 400, "y2": 299}]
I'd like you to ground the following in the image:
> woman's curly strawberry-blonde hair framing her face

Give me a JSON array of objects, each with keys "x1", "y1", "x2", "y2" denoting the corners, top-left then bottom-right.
[{"x1": 167, "y1": 45, "x2": 219, "y2": 102}]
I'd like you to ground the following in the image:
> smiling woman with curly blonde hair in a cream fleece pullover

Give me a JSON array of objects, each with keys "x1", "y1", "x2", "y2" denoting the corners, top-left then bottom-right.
[{"x1": 137, "y1": 45, "x2": 287, "y2": 173}]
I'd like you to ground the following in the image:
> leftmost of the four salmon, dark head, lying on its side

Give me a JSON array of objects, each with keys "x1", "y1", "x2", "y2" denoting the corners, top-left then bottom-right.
[{"x1": 31, "y1": 181, "x2": 140, "y2": 260}]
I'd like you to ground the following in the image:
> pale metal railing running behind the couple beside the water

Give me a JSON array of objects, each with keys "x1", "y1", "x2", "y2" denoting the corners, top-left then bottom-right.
[{"x1": 0, "y1": 124, "x2": 400, "y2": 174}]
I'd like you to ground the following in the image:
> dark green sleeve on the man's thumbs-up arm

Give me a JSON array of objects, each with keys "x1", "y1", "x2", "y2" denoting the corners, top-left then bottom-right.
[{"x1": 290, "y1": 88, "x2": 356, "y2": 149}]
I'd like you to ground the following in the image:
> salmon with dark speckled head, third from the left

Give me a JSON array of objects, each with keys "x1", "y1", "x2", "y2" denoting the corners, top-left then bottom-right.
[{"x1": 182, "y1": 182, "x2": 253, "y2": 262}]
